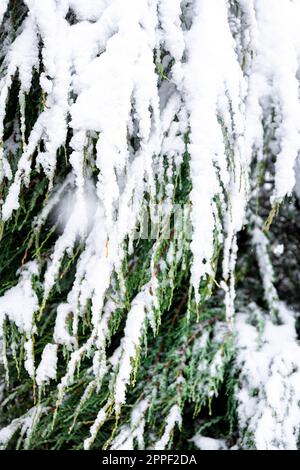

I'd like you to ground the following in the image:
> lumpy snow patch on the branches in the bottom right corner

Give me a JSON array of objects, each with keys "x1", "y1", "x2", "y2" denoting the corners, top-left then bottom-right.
[{"x1": 236, "y1": 303, "x2": 300, "y2": 450}]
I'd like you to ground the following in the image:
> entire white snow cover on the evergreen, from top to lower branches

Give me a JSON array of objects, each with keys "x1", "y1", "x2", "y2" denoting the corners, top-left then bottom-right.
[{"x1": 0, "y1": 0, "x2": 300, "y2": 449}]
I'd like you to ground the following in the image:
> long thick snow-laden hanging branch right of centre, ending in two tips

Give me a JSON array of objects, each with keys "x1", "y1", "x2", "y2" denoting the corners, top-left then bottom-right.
[{"x1": 184, "y1": 0, "x2": 246, "y2": 320}]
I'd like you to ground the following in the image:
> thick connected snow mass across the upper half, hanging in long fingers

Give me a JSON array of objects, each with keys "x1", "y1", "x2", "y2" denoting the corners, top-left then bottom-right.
[{"x1": 0, "y1": 0, "x2": 300, "y2": 308}]
